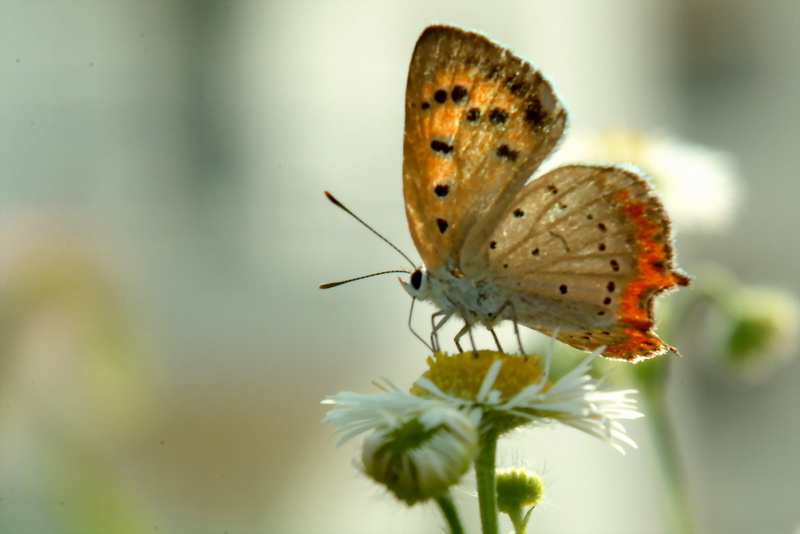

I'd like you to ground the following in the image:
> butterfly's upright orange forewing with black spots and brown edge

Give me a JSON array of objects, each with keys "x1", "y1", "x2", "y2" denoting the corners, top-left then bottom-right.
[{"x1": 403, "y1": 26, "x2": 566, "y2": 275}]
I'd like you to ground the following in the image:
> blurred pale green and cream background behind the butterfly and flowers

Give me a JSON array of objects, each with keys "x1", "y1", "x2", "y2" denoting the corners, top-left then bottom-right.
[{"x1": 0, "y1": 0, "x2": 800, "y2": 534}]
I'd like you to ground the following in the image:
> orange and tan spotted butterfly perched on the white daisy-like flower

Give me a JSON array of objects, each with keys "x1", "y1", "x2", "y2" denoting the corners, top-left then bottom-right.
[{"x1": 332, "y1": 25, "x2": 690, "y2": 361}]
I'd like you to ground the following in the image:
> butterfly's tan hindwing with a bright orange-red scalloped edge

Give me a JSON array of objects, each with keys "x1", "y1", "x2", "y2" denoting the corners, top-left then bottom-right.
[{"x1": 465, "y1": 165, "x2": 689, "y2": 360}]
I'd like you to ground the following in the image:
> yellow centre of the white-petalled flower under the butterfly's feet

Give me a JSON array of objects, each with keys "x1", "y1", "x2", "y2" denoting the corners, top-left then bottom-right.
[{"x1": 411, "y1": 350, "x2": 552, "y2": 401}]
